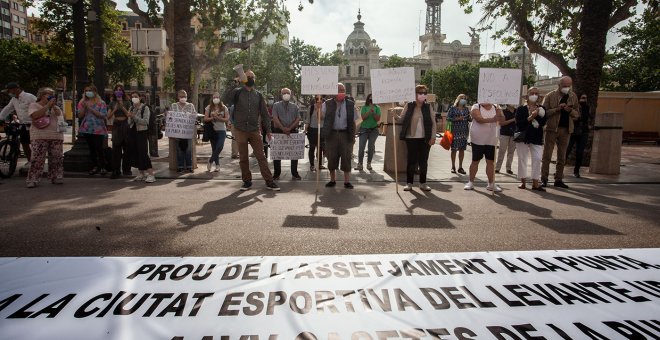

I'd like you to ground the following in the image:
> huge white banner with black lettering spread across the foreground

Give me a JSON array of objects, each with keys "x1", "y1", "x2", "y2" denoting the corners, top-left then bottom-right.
[{"x1": 0, "y1": 248, "x2": 660, "y2": 340}]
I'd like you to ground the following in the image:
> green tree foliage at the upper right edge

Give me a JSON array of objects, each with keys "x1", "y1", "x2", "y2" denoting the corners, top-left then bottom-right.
[{"x1": 602, "y1": 7, "x2": 660, "y2": 92}]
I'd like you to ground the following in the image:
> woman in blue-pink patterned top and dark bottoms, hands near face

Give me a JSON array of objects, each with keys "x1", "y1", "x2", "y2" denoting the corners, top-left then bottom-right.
[{"x1": 76, "y1": 85, "x2": 108, "y2": 175}]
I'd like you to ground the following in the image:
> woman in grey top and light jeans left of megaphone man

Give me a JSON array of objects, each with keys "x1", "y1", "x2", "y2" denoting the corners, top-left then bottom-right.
[{"x1": 204, "y1": 92, "x2": 229, "y2": 172}]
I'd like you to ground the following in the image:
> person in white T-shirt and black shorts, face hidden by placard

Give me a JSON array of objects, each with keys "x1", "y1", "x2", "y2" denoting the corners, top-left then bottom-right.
[{"x1": 463, "y1": 103, "x2": 504, "y2": 192}]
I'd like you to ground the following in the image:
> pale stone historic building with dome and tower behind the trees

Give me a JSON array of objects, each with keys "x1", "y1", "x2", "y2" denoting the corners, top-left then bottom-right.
[{"x1": 337, "y1": 0, "x2": 481, "y2": 100}]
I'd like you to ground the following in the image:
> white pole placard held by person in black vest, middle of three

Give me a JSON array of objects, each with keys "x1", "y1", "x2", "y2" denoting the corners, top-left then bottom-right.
[{"x1": 371, "y1": 67, "x2": 415, "y2": 104}]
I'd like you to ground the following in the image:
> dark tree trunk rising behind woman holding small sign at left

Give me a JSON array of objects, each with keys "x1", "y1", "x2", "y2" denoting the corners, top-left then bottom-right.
[{"x1": 171, "y1": 0, "x2": 193, "y2": 94}]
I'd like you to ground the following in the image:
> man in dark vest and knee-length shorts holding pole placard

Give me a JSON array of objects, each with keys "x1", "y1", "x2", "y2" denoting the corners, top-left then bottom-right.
[{"x1": 321, "y1": 83, "x2": 357, "y2": 189}]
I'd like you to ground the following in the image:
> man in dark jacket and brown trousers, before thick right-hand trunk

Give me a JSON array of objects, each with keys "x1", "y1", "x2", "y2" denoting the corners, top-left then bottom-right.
[{"x1": 541, "y1": 76, "x2": 580, "y2": 189}]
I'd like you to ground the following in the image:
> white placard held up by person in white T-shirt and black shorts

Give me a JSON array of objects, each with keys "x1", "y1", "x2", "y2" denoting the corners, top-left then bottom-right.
[{"x1": 477, "y1": 68, "x2": 522, "y2": 105}]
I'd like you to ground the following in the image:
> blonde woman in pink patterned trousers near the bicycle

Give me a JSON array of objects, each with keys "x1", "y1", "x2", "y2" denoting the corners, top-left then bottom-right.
[{"x1": 26, "y1": 87, "x2": 64, "y2": 188}]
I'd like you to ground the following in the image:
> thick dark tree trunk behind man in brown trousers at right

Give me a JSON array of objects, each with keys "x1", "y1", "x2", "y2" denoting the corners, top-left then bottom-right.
[{"x1": 574, "y1": 0, "x2": 614, "y2": 166}]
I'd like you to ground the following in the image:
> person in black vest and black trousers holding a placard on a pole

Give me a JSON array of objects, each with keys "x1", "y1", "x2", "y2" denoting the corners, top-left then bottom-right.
[{"x1": 396, "y1": 85, "x2": 437, "y2": 191}]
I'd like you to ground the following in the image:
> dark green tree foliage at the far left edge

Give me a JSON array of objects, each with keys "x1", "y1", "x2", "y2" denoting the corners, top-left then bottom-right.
[{"x1": 0, "y1": 39, "x2": 71, "y2": 93}]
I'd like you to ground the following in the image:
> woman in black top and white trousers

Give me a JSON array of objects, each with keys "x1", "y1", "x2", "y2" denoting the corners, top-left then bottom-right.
[{"x1": 515, "y1": 87, "x2": 546, "y2": 191}]
